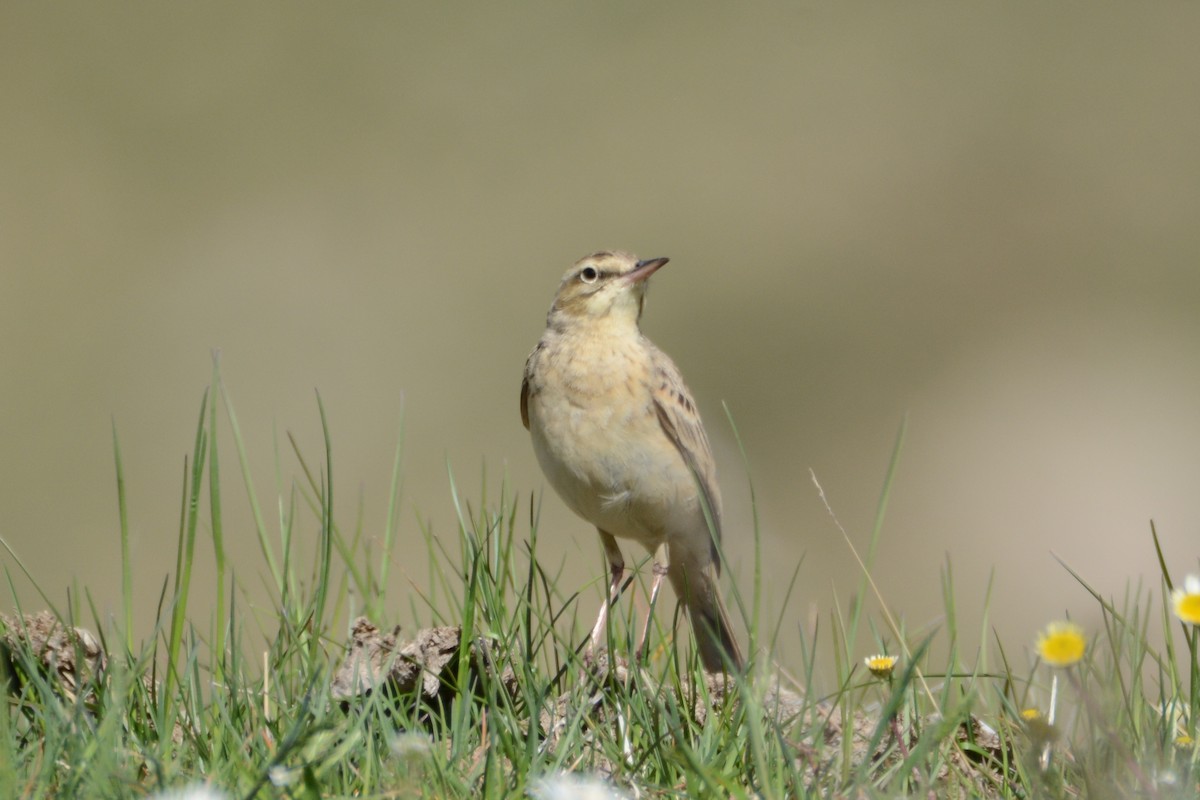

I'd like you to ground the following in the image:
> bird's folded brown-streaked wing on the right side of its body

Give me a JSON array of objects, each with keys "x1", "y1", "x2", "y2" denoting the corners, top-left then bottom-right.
[{"x1": 650, "y1": 345, "x2": 721, "y2": 569}]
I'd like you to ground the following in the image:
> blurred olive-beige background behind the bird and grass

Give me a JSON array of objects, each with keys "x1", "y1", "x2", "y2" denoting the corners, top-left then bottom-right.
[{"x1": 0, "y1": 2, "x2": 1200, "y2": 686}]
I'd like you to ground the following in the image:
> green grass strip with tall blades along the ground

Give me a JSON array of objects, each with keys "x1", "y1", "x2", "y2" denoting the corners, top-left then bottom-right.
[{"x1": 0, "y1": 368, "x2": 1200, "y2": 798}]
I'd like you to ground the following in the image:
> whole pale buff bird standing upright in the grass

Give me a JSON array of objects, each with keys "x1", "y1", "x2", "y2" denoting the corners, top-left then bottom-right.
[{"x1": 521, "y1": 252, "x2": 743, "y2": 670}]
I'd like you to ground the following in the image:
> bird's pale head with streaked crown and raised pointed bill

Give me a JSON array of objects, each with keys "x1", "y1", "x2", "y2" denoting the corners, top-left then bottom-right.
[{"x1": 550, "y1": 251, "x2": 667, "y2": 326}]
